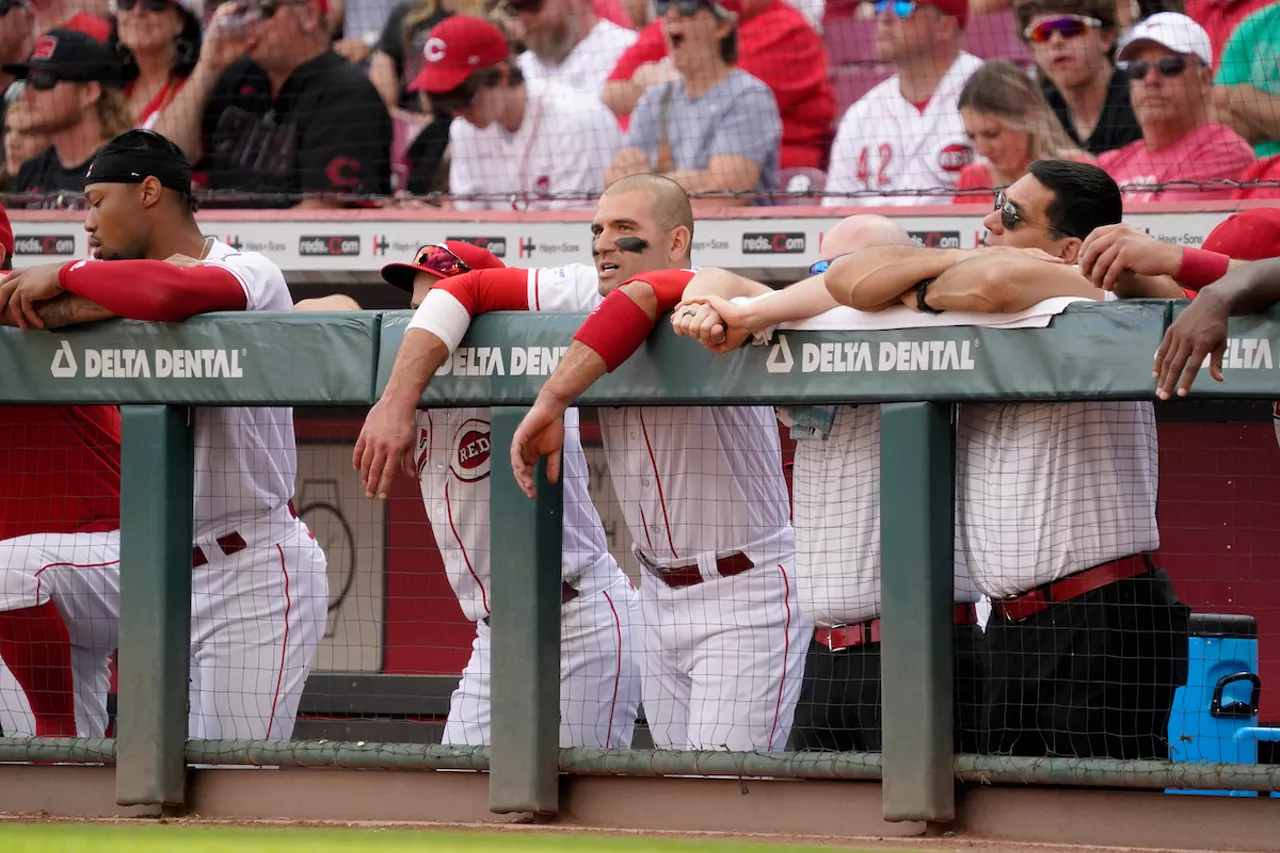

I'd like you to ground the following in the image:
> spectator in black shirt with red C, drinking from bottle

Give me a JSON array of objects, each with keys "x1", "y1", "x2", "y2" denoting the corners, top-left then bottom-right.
[{"x1": 155, "y1": 0, "x2": 392, "y2": 209}]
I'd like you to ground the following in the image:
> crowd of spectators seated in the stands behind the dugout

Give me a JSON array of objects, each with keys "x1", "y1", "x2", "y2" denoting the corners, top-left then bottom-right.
[{"x1": 0, "y1": 0, "x2": 1280, "y2": 210}]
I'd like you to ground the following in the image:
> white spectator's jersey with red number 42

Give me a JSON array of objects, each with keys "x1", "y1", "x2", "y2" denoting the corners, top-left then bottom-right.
[{"x1": 822, "y1": 53, "x2": 982, "y2": 207}]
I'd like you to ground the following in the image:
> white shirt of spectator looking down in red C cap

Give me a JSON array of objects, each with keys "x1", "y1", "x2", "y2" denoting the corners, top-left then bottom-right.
[{"x1": 449, "y1": 79, "x2": 622, "y2": 210}]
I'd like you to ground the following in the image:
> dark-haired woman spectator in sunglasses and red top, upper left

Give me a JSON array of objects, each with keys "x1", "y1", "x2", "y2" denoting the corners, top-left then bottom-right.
[{"x1": 108, "y1": 0, "x2": 201, "y2": 128}]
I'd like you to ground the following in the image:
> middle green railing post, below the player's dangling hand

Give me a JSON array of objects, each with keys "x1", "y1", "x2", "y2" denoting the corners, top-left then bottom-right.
[{"x1": 489, "y1": 406, "x2": 563, "y2": 815}]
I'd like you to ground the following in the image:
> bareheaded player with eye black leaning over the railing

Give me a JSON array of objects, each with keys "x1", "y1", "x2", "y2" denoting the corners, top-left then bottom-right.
[{"x1": 511, "y1": 174, "x2": 812, "y2": 751}]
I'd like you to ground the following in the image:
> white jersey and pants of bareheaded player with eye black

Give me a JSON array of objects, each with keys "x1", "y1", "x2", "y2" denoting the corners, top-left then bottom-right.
[{"x1": 420, "y1": 264, "x2": 812, "y2": 751}]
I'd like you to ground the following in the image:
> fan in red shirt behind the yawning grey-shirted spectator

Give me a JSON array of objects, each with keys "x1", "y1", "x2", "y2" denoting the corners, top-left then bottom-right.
[{"x1": 603, "y1": 0, "x2": 836, "y2": 169}]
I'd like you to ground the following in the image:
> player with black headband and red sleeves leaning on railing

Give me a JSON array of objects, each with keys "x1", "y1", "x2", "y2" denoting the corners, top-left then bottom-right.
[{"x1": 0, "y1": 129, "x2": 328, "y2": 739}]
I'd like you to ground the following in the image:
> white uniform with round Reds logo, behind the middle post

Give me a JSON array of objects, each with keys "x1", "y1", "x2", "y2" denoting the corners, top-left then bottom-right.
[{"x1": 415, "y1": 409, "x2": 640, "y2": 748}]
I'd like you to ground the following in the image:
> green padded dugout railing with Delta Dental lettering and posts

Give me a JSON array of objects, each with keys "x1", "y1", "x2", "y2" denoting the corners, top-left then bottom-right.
[{"x1": 0, "y1": 301, "x2": 1280, "y2": 822}]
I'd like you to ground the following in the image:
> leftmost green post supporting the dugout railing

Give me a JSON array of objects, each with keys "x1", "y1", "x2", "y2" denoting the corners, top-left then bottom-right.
[{"x1": 115, "y1": 406, "x2": 195, "y2": 806}]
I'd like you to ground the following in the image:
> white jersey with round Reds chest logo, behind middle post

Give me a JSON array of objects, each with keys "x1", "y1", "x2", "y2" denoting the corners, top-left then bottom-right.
[{"x1": 413, "y1": 409, "x2": 622, "y2": 621}]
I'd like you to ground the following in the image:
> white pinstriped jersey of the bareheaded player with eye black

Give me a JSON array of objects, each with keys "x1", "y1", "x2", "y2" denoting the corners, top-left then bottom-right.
[{"x1": 527, "y1": 264, "x2": 795, "y2": 576}]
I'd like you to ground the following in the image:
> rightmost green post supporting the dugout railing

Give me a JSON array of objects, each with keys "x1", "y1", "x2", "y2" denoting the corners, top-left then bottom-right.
[{"x1": 881, "y1": 402, "x2": 955, "y2": 821}]
